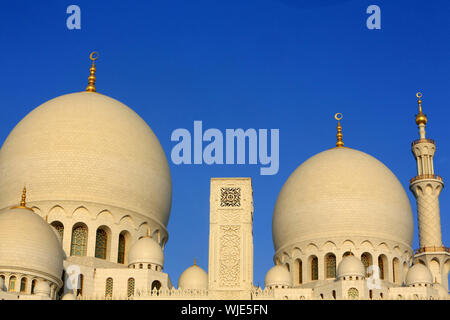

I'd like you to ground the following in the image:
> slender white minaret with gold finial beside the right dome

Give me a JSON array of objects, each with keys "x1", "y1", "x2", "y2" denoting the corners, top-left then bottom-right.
[{"x1": 409, "y1": 92, "x2": 450, "y2": 289}]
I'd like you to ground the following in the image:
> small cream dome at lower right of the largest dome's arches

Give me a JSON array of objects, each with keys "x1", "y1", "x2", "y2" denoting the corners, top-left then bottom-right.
[{"x1": 128, "y1": 237, "x2": 164, "y2": 267}]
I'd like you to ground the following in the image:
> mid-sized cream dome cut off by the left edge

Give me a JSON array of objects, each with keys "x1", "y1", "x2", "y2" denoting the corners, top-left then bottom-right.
[{"x1": 0, "y1": 208, "x2": 64, "y2": 283}]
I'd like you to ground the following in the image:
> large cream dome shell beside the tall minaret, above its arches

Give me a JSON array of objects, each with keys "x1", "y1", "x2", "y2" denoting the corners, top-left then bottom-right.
[{"x1": 272, "y1": 147, "x2": 413, "y2": 251}]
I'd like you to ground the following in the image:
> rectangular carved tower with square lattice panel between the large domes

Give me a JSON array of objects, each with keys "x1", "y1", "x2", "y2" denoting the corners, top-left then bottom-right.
[{"x1": 208, "y1": 178, "x2": 253, "y2": 299}]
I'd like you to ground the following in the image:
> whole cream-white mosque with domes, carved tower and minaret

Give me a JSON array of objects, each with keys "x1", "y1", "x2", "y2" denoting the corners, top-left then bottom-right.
[{"x1": 0, "y1": 55, "x2": 450, "y2": 300}]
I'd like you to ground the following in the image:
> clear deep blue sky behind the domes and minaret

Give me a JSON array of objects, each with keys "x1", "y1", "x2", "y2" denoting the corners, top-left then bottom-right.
[{"x1": 0, "y1": 0, "x2": 450, "y2": 285}]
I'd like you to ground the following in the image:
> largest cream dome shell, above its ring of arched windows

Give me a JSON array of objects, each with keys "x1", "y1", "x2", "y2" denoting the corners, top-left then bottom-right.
[{"x1": 0, "y1": 92, "x2": 172, "y2": 226}]
